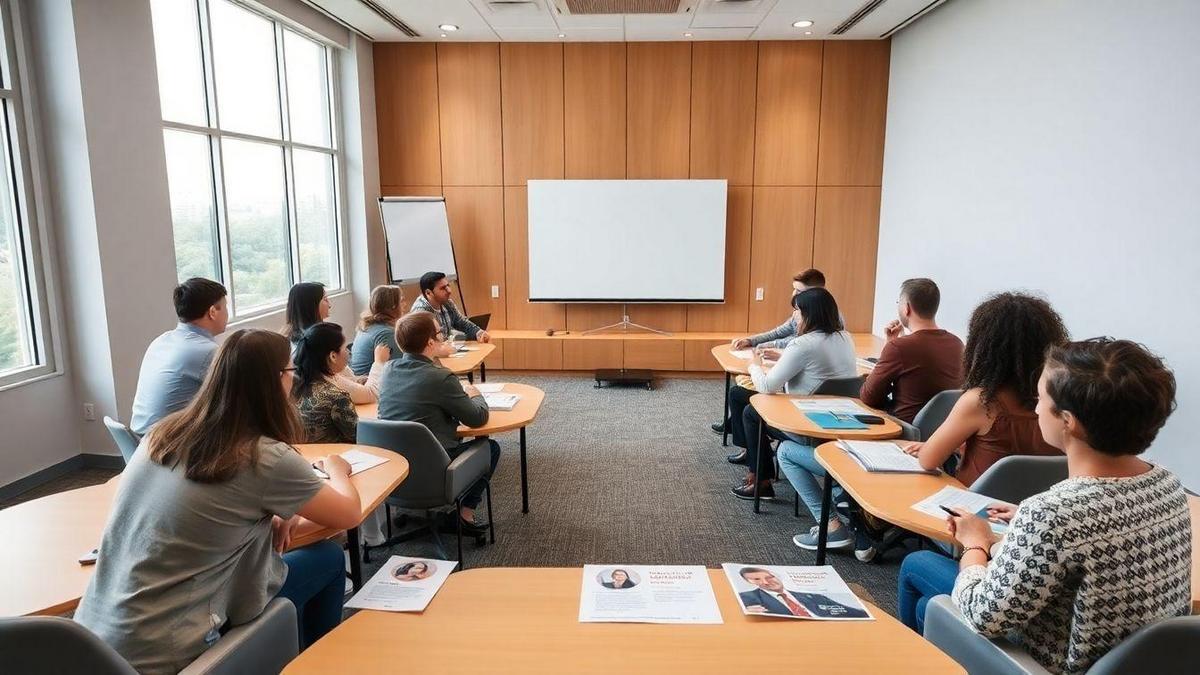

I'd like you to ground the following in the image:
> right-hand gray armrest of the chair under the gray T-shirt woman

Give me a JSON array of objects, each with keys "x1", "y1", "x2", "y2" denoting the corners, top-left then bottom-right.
[{"x1": 180, "y1": 598, "x2": 300, "y2": 675}]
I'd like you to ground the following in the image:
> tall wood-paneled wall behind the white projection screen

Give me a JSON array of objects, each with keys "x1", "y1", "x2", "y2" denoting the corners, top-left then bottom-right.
[{"x1": 374, "y1": 41, "x2": 890, "y2": 338}]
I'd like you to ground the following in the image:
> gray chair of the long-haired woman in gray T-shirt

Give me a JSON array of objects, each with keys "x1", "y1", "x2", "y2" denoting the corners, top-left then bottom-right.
[{"x1": 0, "y1": 598, "x2": 300, "y2": 675}]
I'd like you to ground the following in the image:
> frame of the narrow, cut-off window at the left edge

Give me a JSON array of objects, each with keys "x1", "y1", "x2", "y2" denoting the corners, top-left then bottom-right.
[{"x1": 0, "y1": 0, "x2": 61, "y2": 392}]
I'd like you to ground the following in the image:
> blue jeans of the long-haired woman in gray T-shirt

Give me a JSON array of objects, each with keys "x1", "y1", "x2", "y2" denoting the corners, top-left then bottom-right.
[{"x1": 276, "y1": 539, "x2": 343, "y2": 650}]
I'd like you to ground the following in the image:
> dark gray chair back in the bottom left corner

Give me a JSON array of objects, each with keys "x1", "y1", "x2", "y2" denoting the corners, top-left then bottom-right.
[{"x1": 0, "y1": 612, "x2": 137, "y2": 675}]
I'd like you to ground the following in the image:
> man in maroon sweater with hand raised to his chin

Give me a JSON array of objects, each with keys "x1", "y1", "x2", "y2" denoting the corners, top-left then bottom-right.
[{"x1": 860, "y1": 279, "x2": 962, "y2": 424}]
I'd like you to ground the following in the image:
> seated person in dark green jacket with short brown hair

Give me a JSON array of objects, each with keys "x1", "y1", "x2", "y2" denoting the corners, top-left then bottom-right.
[{"x1": 379, "y1": 312, "x2": 500, "y2": 536}]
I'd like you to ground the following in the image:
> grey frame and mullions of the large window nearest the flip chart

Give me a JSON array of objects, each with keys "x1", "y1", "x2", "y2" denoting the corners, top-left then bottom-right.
[{"x1": 162, "y1": 0, "x2": 348, "y2": 323}]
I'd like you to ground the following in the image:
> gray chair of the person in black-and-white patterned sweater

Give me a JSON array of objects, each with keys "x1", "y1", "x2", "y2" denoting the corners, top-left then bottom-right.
[{"x1": 925, "y1": 596, "x2": 1200, "y2": 675}]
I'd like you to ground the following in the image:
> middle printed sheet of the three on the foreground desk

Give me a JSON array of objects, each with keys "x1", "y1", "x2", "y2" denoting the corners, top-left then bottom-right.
[{"x1": 580, "y1": 565, "x2": 724, "y2": 623}]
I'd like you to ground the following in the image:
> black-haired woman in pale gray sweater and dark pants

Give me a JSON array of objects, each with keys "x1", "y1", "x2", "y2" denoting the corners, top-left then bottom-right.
[{"x1": 730, "y1": 288, "x2": 858, "y2": 499}]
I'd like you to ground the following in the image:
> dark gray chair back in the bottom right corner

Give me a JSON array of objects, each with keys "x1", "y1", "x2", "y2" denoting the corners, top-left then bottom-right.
[{"x1": 1087, "y1": 616, "x2": 1200, "y2": 675}]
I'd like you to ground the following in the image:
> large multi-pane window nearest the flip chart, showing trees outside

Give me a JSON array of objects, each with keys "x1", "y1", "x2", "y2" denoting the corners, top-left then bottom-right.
[{"x1": 152, "y1": 0, "x2": 342, "y2": 317}]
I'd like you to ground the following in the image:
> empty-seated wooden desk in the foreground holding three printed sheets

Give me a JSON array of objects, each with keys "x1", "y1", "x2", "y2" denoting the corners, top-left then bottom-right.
[{"x1": 283, "y1": 567, "x2": 964, "y2": 675}]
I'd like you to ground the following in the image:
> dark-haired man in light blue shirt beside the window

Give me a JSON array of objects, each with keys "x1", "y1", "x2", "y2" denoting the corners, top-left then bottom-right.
[{"x1": 130, "y1": 277, "x2": 229, "y2": 436}]
